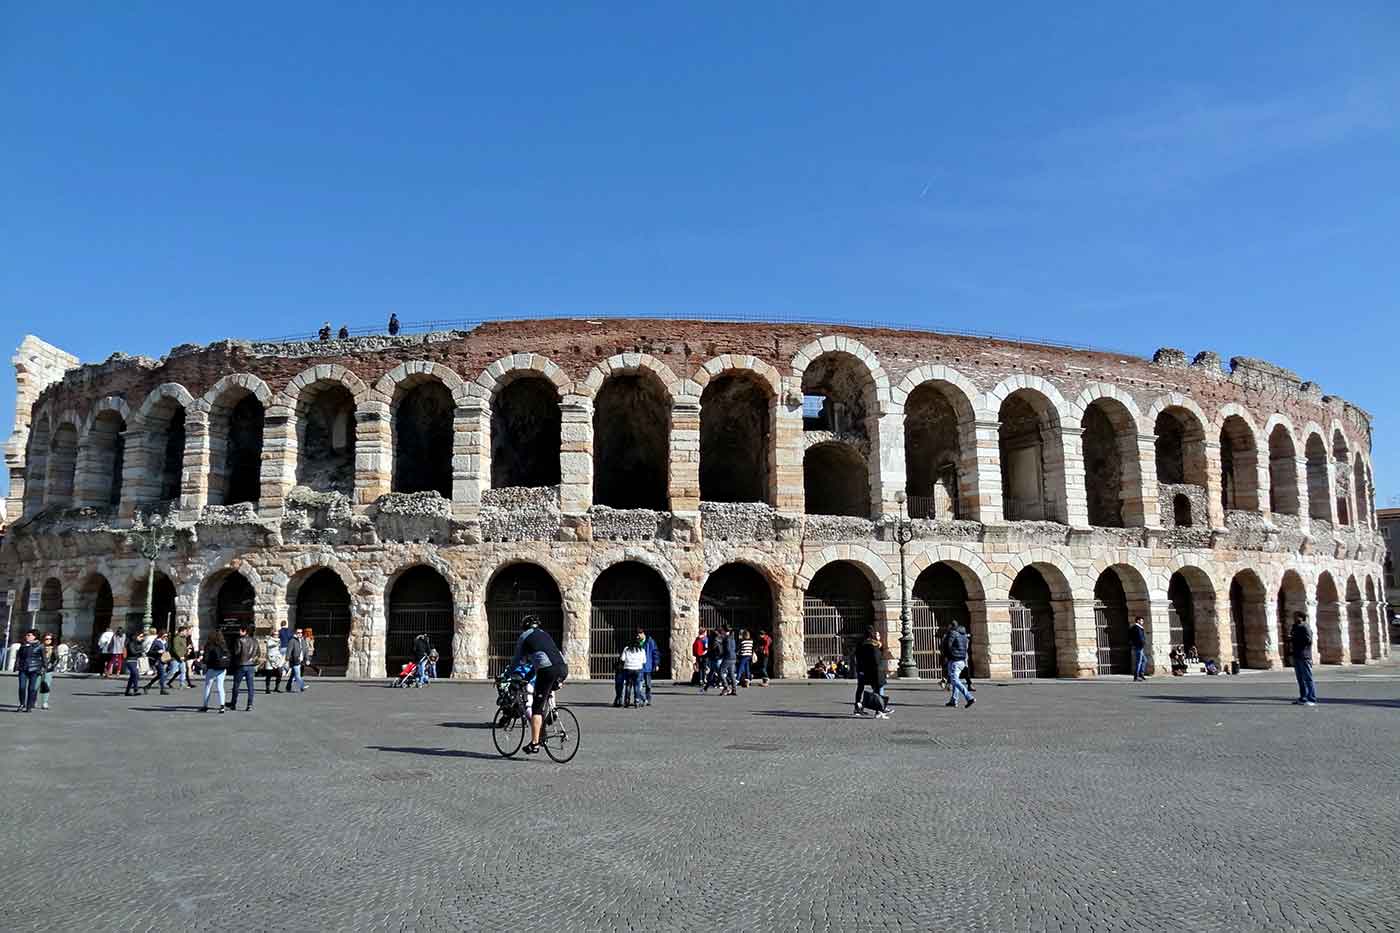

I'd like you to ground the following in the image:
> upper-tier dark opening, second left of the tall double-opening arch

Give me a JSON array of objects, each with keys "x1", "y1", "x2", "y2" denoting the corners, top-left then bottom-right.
[{"x1": 594, "y1": 373, "x2": 671, "y2": 509}]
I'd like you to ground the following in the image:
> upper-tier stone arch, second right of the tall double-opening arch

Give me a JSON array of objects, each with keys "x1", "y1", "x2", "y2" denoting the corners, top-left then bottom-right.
[{"x1": 986, "y1": 374, "x2": 1085, "y2": 524}]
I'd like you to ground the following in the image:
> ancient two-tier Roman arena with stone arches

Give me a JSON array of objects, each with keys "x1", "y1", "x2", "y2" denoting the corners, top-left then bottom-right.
[{"x1": 0, "y1": 319, "x2": 1389, "y2": 678}]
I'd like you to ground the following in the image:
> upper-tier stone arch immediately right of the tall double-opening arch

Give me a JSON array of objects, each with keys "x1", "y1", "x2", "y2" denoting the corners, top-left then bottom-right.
[{"x1": 890, "y1": 364, "x2": 981, "y2": 518}]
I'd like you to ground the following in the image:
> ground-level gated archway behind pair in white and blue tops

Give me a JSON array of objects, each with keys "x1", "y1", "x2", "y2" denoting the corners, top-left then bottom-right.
[{"x1": 588, "y1": 560, "x2": 671, "y2": 681}]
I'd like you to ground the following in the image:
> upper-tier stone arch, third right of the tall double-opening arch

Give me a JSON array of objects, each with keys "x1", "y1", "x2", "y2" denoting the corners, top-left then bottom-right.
[{"x1": 1071, "y1": 382, "x2": 1156, "y2": 528}]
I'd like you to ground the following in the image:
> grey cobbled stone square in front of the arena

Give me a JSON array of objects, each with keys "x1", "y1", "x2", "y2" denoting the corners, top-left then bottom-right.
[{"x1": 8, "y1": 667, "x2": 1400, "y2": 930}]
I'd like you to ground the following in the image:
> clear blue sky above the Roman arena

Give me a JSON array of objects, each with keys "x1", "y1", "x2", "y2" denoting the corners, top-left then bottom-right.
[{"x1": 0, "y1": 0, "x2": 1400, "y2": 504}]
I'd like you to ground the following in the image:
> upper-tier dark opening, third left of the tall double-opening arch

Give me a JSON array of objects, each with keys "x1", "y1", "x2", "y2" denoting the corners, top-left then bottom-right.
[{"x1": 491, "y1": 377, "x2": 561, "y2": 490}]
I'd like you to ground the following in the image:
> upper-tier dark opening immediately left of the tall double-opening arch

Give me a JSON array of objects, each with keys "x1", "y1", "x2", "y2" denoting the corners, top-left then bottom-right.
[{"x1": 700, "y1": 373, "x2": 773, "y2": 502}]
